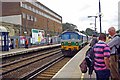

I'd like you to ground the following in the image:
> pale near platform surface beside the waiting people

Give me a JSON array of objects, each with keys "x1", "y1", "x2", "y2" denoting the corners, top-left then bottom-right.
[{"x1": 52, "y1": 45, "x2": 95, "y2": 80}]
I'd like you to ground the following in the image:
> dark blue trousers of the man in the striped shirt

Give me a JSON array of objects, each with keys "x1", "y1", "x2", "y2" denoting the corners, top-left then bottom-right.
[{"x1": 95, "y1": 69, "x2": 110, "y2": 80}]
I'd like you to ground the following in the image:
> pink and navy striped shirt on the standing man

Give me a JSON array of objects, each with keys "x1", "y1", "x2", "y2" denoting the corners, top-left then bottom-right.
[{"x1": 94, "y1": 41, "x2": 110, "y2": 70}]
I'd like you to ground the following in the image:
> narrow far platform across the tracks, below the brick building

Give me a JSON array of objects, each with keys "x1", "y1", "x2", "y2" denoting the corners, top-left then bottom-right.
[{"x1": 0, "y1": 44, "x2": 61, "y2": 58}]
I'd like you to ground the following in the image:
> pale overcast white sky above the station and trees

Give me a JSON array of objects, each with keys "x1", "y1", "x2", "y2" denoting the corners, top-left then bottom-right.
[{"x1": 38, "y1": 0, "x2": 120, "y2": 33}]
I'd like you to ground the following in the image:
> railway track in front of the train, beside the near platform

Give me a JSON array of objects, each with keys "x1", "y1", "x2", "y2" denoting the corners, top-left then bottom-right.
[{"x1": 30, "y1": 58, "x2": 71, "y2": 80}]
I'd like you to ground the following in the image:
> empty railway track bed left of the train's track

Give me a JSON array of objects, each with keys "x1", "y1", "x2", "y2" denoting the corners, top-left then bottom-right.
[{"x1": 0, "y1": 49, "x2": 63, "y2": 80}]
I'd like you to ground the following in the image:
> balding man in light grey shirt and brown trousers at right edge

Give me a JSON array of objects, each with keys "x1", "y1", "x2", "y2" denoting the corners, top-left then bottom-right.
[{"x1": 108, "y1": 27, "x2": 120, "y2": 80}]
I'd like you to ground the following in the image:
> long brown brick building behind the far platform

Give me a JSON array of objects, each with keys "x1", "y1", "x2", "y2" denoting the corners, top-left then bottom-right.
[{"x1": 0, "y1": 0, "x2": 62, "y2": 36}]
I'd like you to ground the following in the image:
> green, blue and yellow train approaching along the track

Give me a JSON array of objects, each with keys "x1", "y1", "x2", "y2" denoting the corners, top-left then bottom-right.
[{"x1": 60, "y1": 30, "x2": 88, "y2": 57}]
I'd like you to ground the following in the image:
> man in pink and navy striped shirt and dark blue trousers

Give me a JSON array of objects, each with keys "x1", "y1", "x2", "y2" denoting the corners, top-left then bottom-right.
[{"x1": 93, "y1": 33, "x2": 110, "y2": 80}]
